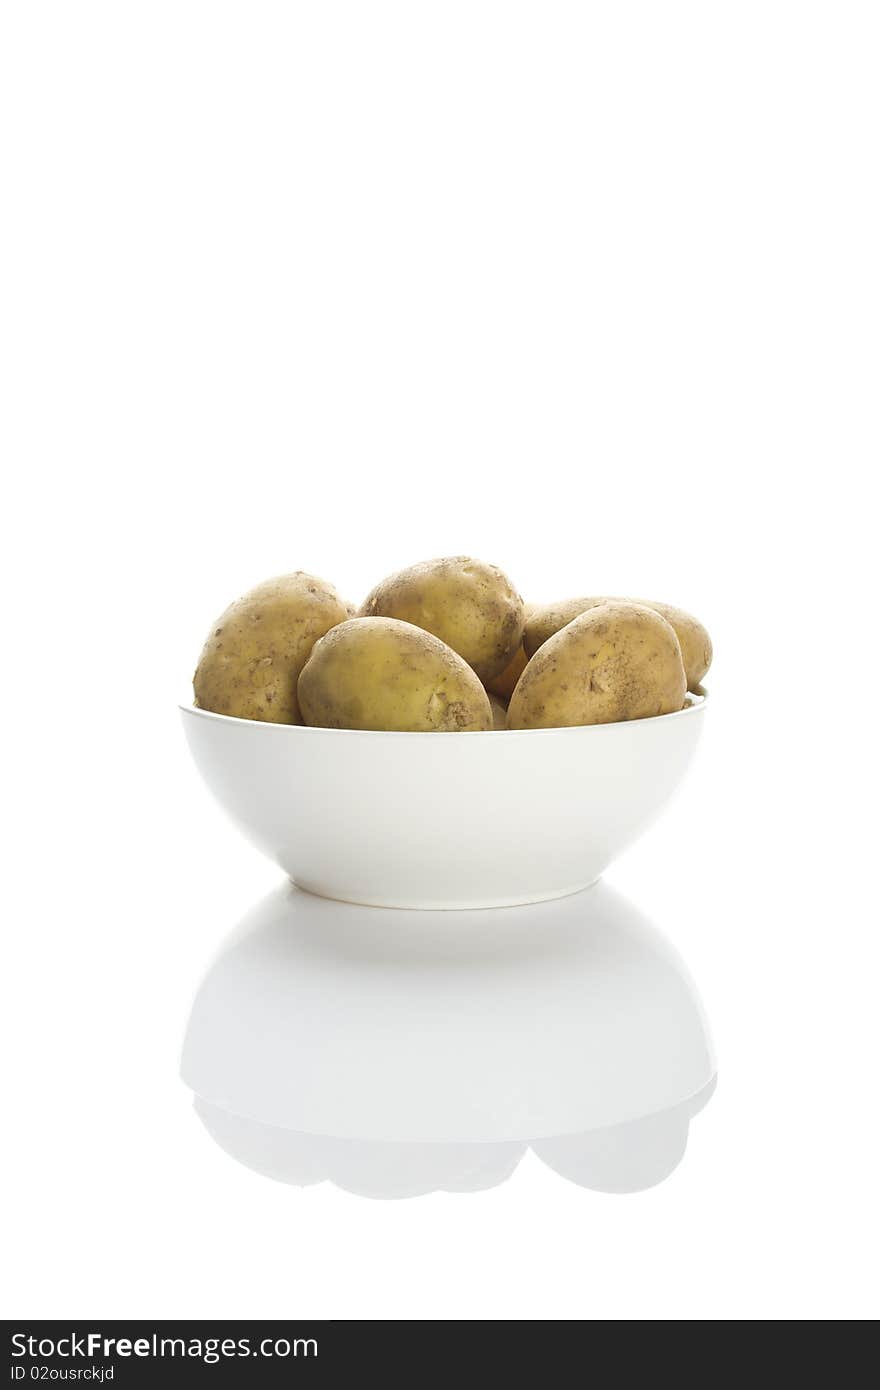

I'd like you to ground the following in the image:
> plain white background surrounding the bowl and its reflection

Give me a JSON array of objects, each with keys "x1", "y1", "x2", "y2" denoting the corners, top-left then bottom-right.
[{"x1": 0, "y1": 0, "x2": 880, "y2": 1319}]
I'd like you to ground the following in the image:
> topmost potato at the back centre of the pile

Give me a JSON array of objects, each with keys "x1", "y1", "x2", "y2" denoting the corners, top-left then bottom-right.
[{"x1": 360, "y1": 556, "x2": 523, "y2": 681}]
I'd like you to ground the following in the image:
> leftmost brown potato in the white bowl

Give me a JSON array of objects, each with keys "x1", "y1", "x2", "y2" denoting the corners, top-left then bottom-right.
[{"x1": 193, "y1": 570, "x2": 348, "y2": 724}]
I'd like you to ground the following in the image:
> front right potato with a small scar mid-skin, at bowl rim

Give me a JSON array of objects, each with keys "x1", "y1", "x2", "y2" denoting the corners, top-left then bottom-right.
[{"x1": 507, "y1": 602, "x2": 687, "y2": 728}]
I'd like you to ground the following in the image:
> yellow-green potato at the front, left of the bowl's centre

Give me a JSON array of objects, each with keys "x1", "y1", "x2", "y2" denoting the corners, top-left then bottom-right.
[{"x1": 299, "y1": 617, "x2": 492, "y2": 733}]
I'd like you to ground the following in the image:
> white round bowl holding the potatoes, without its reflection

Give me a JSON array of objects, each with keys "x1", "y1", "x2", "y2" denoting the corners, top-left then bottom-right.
[{"x1": 181, "y1": 696, "x2": 705, "y2": 908}]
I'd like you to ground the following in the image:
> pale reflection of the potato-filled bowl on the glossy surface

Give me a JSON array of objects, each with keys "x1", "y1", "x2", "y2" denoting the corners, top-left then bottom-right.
[{"x1": 182, "y1": 883, "x2": 715, "y2": 1197}]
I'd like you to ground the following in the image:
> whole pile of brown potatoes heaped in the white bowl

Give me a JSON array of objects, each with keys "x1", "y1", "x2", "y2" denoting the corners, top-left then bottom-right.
[{"x1": 193, "y1": 556, "x2": 712, "y2": 733}]
